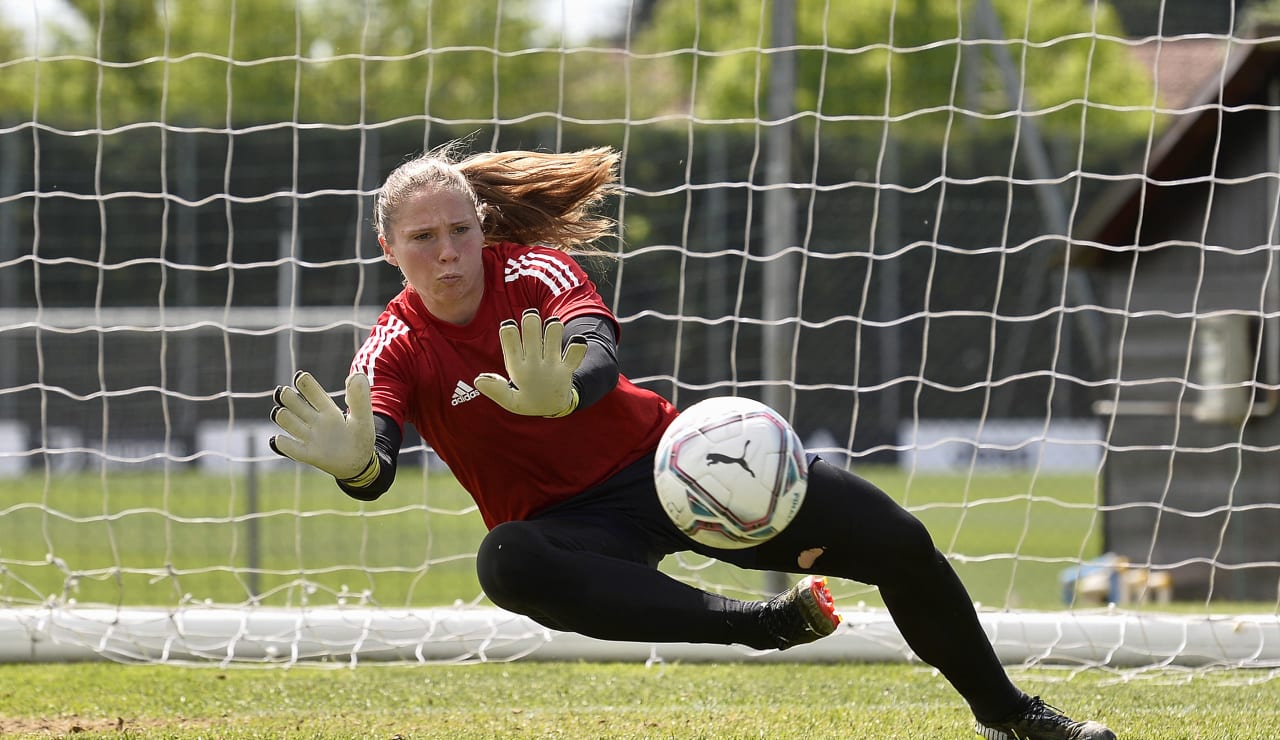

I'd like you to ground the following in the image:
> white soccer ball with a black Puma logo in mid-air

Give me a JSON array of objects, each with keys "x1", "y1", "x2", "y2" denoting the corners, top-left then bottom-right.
[{"x1": 654, "y1": 397, "x2": 809, "y2": 549}]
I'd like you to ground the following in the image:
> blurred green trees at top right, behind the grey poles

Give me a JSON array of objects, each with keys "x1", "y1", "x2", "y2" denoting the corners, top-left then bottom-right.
[{"x1": 637, "y1": 0, "x2": 1153, "y2": 156}]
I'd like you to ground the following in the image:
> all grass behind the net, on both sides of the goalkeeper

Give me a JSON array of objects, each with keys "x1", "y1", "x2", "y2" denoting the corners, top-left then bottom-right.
[{"x1": 0, "y1": 467, "x2": 1274, "y2": 611}]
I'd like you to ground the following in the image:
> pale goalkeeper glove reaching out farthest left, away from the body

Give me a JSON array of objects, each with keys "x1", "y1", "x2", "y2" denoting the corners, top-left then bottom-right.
[{"x1": 269, "y1": 370, "x2": 379, "y2": 488}]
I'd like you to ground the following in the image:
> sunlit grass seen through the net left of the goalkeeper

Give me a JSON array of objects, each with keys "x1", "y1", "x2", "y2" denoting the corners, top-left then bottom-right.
[{"x1": 0, "y1": 471, "x2": 484, "y2": 606}]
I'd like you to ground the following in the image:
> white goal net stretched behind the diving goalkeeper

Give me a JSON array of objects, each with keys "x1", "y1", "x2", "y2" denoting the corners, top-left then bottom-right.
[{"x1": 0, "y1": 0, "x2": 1280, "y2": 670}]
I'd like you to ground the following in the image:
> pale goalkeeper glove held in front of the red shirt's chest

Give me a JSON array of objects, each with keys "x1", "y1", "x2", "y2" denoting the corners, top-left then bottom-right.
[{"x1": 474, "y1": 309, "x2": 586, "y2": 419}]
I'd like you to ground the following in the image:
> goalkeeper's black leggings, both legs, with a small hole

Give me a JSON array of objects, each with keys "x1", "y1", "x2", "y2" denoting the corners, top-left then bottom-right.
[{"x1": 476, "y1": 458, "x2": 1023, "y2": 717}]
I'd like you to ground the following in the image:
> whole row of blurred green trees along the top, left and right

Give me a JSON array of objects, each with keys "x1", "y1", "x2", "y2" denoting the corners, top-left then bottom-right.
[{"x1": 0, "y1": 0, "x2": 1153, "y2": 159}]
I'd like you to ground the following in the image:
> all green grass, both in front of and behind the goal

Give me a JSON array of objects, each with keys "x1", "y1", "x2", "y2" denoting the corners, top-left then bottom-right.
[{"x1": 0, "y1": 469, "x2": 1280, "y2": 740}]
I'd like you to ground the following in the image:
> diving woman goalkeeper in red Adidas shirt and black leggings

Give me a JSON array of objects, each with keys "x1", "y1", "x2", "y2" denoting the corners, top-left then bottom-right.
[{"x1": 270, "y1": 142, "x2": 1115, "y2": 740}]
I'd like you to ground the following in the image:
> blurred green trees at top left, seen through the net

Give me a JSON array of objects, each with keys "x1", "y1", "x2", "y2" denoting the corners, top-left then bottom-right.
[{"x1": 0, "y1": 0, "x2": 557, "y2": 128}]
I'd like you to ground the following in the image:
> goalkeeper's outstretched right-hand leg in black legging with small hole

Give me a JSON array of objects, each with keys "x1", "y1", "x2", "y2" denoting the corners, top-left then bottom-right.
[{"x1": 732, "y1": 460, "x2": 1025, "y2": 717}]
